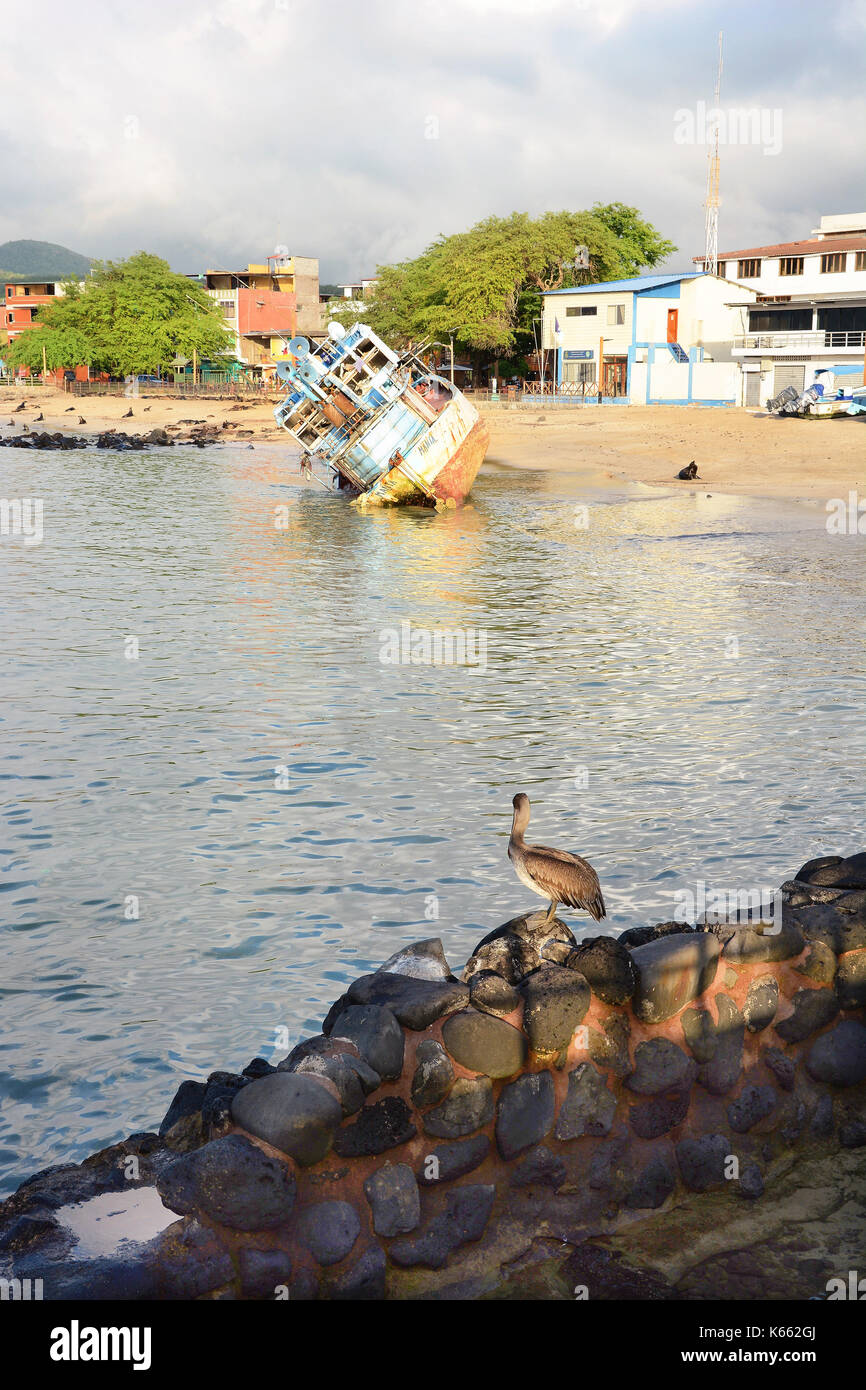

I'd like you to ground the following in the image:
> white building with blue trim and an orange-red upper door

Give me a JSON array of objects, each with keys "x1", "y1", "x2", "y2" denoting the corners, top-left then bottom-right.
[{"x1": 542, "y1": 271, "x2": 758, "y2": 406}]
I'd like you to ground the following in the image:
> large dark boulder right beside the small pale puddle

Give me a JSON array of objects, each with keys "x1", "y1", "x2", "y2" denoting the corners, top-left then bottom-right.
[{"x1": 156, "y1": 1134, "x2": 296, "y2": 1230}]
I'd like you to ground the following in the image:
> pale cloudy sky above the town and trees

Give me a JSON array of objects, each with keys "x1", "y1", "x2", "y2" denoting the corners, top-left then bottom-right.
[{"x1": 0, "y1": 0, "x2": 866, "y2": 281}]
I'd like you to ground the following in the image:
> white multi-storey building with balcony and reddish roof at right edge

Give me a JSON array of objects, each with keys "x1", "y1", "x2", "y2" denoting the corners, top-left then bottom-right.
[{"x1": 695, "y1": 213, "x2": 866, "y2": 406}]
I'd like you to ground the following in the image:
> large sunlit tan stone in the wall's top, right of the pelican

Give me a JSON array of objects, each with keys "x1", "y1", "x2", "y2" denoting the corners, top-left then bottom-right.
[{"x1": 631, "y1": 931, "x2": 721, "y2": 1023}]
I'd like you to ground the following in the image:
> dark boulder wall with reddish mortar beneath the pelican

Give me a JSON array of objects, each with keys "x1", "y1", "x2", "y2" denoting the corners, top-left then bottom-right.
[{"x1": 0, "y1": 853, "x2": 866, "y2": 1300}]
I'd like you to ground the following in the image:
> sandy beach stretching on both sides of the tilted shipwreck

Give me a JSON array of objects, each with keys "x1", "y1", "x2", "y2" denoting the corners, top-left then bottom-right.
[{"x1": 0, "y1": 386, "x2": 866, "y2": 499}]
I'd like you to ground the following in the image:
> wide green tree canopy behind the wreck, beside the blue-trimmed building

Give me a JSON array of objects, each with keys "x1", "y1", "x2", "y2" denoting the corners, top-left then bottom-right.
[{"x1": 335, "y1": 203, "x2": 676, "y2": 356}]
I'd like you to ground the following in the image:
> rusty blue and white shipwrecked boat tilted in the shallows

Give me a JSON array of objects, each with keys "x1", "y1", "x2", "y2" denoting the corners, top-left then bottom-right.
[{"x1": 274, "y1": 322, "x2": 489, "y2": 509}]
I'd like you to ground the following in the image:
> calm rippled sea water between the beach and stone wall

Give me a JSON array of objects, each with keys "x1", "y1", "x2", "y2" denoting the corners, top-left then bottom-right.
[{"x1": 0, "y1": 446, "x2": 866, "y2": 1188}]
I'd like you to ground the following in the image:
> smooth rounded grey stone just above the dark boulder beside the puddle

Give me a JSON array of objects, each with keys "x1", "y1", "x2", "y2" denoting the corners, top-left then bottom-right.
[{"x1": 232, "y1": 1072, "x2": 343, "y2": 1168}]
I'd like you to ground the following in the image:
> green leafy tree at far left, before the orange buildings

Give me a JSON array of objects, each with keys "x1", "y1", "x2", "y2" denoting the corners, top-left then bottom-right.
[{"x1": 6, "y1": 252, "x2": 231, "y2": 377}]
